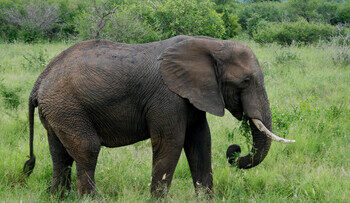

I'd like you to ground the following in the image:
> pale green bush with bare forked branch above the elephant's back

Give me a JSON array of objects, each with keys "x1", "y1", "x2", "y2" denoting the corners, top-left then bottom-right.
[{"x1": 75, "y1": 1, "x2": 159, "y2": 43}]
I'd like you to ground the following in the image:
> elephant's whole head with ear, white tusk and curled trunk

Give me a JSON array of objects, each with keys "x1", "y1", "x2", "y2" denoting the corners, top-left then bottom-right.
[{"x1": 160, "y1": 38, "x2": 294, "y2": 169}]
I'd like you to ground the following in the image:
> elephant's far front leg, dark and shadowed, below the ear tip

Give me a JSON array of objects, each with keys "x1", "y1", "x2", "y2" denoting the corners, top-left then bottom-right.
[{"x1": 184, "y1": 112, "x2": 213, "y2": 196}]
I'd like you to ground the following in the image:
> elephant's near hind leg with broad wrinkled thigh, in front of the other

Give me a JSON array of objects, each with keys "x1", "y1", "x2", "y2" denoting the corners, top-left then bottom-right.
[{"x1": 46, "y1": 108, "x2": 101, "y2": 195}]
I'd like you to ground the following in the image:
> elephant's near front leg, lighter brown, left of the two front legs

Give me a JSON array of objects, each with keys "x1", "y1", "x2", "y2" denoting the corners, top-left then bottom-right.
[{"x1": 150, "y1": 116, "x2": 186, "y2": 198}]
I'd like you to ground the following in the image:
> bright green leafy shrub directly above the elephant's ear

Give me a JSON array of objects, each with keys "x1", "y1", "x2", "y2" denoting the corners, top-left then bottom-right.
[{"x1": 153, "y1": 0, "x2": 226, "y2": 38}]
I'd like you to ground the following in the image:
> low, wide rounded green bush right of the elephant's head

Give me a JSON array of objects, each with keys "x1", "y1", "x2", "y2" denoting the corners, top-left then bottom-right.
[{"x1": 253, "y1": 19, "x2": 336, "y2": 44}]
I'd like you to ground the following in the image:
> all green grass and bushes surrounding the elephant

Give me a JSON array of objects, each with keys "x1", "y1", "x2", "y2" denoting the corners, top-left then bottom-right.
[{"x1": 0, "y1": 0, "x2": 350, "y2": 202}]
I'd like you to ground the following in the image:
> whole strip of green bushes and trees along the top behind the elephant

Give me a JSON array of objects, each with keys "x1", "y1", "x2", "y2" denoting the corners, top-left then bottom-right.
[{"x1": 0, "y1": 0, "x2": 350, "y2": 44}]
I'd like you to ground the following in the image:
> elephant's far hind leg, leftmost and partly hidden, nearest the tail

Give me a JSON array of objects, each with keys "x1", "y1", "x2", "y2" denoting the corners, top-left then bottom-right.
[{"x1": 47, "y1": 128, "x2": 73, "y2": 197}]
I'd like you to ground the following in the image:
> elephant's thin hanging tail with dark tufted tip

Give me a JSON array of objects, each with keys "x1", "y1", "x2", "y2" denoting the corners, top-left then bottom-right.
[{"x1": 23, "y1": 97, "x2": 37, "y2": 176}]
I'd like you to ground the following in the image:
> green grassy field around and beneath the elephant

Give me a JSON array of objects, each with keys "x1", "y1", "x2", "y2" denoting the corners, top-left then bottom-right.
[{"x1": 0, "y1": 38, "x2": 350, "y2": 202}]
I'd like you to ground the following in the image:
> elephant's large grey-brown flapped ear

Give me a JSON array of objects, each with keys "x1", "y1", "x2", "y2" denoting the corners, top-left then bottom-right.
[{"x1": 160, "y1": 39, "x2": 225, "y2": 116}]
